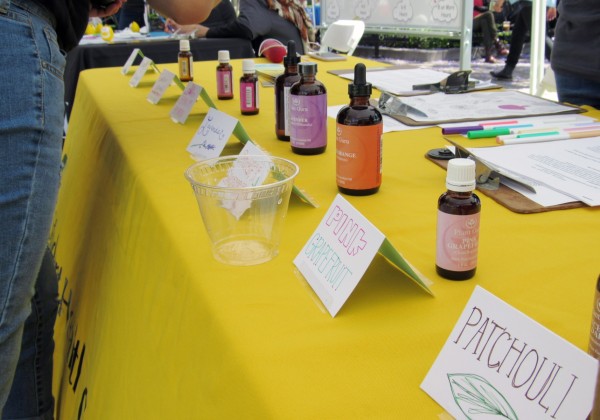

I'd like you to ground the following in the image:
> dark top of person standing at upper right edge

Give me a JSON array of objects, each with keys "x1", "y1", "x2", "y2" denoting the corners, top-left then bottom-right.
[{"x1": 552, "y1": 0, "x2": 600, "y2": 83}]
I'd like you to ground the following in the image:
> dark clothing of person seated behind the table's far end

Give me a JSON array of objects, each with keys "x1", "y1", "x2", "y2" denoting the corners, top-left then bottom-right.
[{"x1": 206, "y1": 0, "x2": 304, "y2": 54}]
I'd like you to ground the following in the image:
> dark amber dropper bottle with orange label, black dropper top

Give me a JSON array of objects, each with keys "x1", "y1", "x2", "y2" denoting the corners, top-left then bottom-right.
[{"x1": 335, "y1": 63, "x2": 383, "y2": 195}]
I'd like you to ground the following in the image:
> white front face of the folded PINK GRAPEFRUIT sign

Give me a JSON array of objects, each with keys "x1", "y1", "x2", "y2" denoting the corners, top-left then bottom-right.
[{"x1": 294, "y1": 194, "x2": 385, "y2": 316}]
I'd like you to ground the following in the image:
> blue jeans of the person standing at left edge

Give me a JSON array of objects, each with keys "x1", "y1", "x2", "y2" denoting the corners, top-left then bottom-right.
[{"x1": 0, "y1": 0, "x2": 65, "y2": 419}]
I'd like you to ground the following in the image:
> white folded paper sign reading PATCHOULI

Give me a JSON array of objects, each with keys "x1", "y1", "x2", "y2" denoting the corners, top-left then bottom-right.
[{"x1": 421, "y1": 286, "x2": 598, "y2": 420}]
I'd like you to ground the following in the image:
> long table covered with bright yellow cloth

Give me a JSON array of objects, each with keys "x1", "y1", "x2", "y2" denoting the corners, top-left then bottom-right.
[{"x1": 52, "y1": 57, "x2": 600, "y2": 420}]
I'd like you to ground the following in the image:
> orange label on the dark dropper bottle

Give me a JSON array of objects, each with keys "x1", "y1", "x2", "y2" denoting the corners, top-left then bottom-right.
[{"x1": 335, "y1": 123, "x2": 383, "y2": 190}]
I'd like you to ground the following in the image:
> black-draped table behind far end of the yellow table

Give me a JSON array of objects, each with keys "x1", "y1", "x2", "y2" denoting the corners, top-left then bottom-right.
[{"x1": 65, "y1": 38, "x2": 255, "y2": 115}]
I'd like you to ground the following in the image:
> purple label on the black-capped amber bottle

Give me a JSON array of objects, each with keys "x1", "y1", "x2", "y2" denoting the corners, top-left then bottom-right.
[{"x1": 289, "y1": 94, "x2": 327, "y2": 149}]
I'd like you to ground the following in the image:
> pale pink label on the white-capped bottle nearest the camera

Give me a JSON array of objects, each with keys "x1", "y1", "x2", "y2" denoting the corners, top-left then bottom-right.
[{"x1": 435, "y1": 211, "x2": 480, "y2": 271}]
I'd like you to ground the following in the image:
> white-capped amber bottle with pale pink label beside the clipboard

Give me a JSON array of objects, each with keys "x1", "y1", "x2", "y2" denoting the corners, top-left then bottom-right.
[{"x1": 435, "y1": 158, "x2": 481, "y2": 280}]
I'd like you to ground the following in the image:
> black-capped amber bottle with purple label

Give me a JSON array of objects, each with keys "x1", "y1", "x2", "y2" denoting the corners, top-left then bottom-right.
[{"x1": 289, "y1": 63, "x2": 327, "y2": 155}]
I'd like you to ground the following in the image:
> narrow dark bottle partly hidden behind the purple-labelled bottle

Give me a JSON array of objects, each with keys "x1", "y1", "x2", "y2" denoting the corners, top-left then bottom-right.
[{"x1": 275, "y1": 41, "x2": 300, "y2": 141}]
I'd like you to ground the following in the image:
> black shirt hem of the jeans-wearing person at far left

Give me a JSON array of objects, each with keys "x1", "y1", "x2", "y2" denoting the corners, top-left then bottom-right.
[{"x1": 32, "y1": 0, "x2": 90, "y2": 51}]
